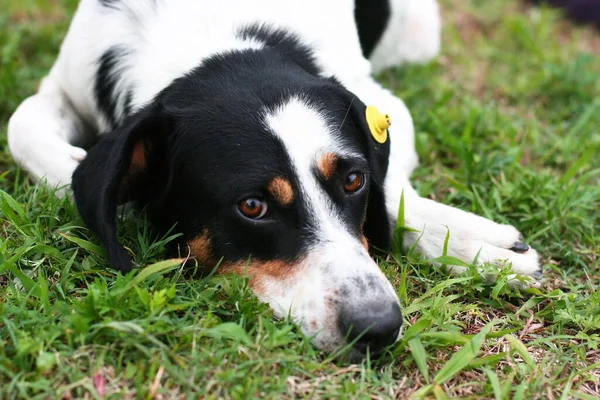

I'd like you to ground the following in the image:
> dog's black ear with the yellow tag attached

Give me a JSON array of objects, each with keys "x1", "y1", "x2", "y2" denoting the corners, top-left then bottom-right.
[{"x1": 351, "y1": 98, "x2": 392, "y2": 251}]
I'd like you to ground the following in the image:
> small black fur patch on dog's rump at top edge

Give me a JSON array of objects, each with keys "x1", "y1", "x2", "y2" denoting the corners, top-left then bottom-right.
[{"x1": 354, "y1": 0, "x2": 391, "y2": 58}]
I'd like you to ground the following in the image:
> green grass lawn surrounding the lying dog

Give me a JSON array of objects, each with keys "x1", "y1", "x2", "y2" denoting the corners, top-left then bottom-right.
[{"x1": 0, "y1": 0, "x2": 600, "y2": 399}]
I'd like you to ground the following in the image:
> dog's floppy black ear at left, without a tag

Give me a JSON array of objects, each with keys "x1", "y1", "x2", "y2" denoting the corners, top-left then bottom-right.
[{"x1": 72, "y1": 103, "x2": 173, "y2": 273}]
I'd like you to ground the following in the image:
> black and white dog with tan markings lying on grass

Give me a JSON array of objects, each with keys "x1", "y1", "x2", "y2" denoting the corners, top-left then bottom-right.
[{"x1": 9, "y1": 0, "x2": 542, "y2": 356}]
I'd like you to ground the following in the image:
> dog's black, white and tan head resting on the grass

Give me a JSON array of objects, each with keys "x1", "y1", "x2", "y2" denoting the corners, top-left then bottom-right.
[{"x1": 73, "y1": 47, "x2": 402, "y2": 355}]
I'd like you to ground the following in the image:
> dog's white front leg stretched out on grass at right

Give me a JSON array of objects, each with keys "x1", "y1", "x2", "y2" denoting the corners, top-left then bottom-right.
[{"x1": 385, "y1": 106, "x2": 542, "y2": 285}]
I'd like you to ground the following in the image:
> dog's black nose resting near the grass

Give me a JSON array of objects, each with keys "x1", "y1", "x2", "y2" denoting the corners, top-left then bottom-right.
[{"x1": 339, "y1": 302, "x2": 402, "y2": 354}]
